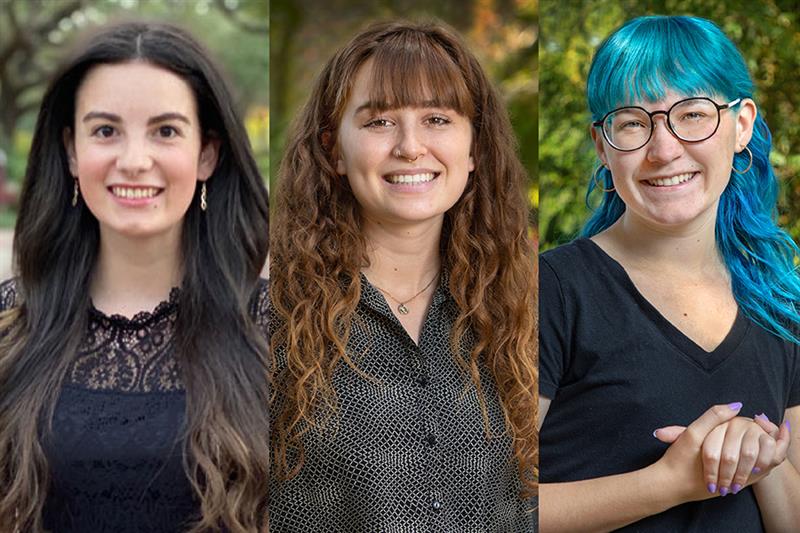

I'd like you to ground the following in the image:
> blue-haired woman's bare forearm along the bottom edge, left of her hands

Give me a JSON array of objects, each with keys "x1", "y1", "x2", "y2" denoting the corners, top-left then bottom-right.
[{"x1": 539, "y1": 465, "x2": 681, "y2": 533}]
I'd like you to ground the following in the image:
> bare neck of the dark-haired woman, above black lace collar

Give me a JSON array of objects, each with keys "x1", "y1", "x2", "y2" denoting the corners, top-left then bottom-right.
[{"x1": 90, "y1": 228, "x2": 181, "y2": 317}]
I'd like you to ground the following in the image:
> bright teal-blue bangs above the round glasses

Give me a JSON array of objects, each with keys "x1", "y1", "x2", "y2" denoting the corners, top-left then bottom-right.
[{"x1": 587, "y1": 17, "x2": 752, "y2": 120}]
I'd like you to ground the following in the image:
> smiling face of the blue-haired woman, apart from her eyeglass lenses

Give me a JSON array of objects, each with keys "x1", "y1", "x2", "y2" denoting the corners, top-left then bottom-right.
[{"x1": 592, "y1": 91, "x2": 756, "y2": 228}]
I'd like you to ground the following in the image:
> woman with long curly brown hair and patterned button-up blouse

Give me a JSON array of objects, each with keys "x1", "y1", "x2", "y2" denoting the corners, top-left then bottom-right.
[{"x1": 270, "y1": 19, "x2": 537, "y2": 533}]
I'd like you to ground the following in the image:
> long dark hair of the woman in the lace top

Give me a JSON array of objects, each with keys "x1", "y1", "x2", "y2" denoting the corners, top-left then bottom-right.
[{"x1": 0, "y1": 23, "x2": 269, "y2": 532}]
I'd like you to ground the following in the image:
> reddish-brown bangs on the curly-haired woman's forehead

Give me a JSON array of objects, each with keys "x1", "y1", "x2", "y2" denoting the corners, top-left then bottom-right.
[{"x1": 360, "y1": 31, "x2": 475, "y2": 119}]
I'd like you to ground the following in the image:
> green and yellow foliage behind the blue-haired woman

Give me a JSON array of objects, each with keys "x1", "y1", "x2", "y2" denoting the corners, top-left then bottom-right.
[{"x1": 539, "y1": 0, "x2": 800, "y2": 250}]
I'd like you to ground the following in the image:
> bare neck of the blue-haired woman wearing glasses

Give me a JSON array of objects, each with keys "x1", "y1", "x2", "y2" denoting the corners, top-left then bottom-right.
[{"x1": 597, "y1": 210, "x2": 726, "y2": 273}]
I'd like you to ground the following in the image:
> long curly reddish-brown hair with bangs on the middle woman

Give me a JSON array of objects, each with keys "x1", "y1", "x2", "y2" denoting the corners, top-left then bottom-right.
[{"x1": 270, "y1": 22, "x2": 538, "y2": 494}]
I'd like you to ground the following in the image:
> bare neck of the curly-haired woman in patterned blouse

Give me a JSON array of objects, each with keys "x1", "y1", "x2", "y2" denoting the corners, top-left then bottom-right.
[{"x1": 363, "y1": 215, "x2": 442, "y2": 294}]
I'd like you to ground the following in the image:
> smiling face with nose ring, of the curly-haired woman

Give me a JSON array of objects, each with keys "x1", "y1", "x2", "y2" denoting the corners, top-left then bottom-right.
[{"x1": 336, "y1": 61, "x2": 475, "y2": 229}]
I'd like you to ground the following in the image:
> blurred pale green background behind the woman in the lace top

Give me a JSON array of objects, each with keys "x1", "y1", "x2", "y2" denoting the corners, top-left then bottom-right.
[{"x1": 0, "y1": 0, "x2": 269, "y2": 222}]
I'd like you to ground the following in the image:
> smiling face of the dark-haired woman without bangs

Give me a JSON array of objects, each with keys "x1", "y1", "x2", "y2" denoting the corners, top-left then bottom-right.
[{"x1": 64, "y1": 62, "x2": 216, "y2": 242}]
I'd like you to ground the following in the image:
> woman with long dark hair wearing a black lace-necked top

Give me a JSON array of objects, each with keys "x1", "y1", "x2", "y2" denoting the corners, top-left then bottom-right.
[{"x1": 0, "y1": 23, "x2": 269, "y2": 532}]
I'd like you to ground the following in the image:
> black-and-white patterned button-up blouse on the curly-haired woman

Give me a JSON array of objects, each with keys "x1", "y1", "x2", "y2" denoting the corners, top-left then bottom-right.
[{"x1": 270, "y1": 276, "x2": 535, "y2": 533}]
